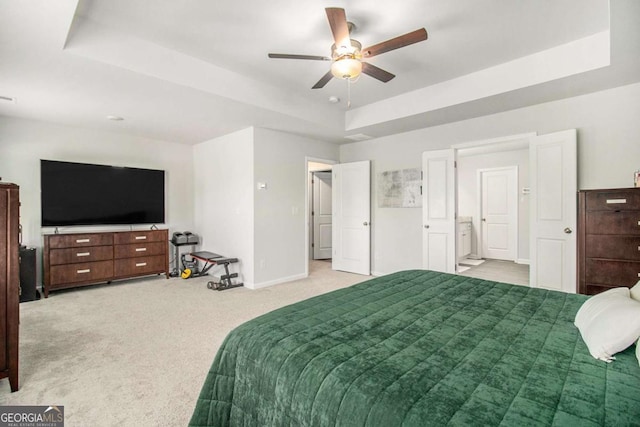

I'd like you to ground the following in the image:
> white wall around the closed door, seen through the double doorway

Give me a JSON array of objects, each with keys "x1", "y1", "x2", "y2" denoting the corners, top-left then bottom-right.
[{"x1": 458, "y1": 149, "x2": 529, "y2": 262}]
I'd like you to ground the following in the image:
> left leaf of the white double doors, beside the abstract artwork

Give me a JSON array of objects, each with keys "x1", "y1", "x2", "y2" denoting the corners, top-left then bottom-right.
[{"x1": 422, "y1": 149, "x2": 456, "y2": 273}]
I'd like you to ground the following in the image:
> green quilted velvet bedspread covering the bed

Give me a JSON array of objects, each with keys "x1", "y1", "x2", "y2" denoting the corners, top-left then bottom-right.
[{"x1": 190, "y1": 270, "x2": 640, "y2": 427}]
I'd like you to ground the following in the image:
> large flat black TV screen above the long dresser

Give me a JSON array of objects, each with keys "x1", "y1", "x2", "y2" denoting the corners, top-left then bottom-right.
[{"x1": 40, "y1": 160, "x2": 164, "y2": 227}]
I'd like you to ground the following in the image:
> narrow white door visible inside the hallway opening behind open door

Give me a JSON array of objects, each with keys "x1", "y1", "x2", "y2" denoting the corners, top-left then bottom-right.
[{"x1": 311, "y1": 172, "x2": 332, "y2": 259}]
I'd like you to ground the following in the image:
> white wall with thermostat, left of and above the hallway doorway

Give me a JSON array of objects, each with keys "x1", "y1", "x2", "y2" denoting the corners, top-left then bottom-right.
[{"x1": 253, "y1": 128, "x2": 339, "y2": 287}]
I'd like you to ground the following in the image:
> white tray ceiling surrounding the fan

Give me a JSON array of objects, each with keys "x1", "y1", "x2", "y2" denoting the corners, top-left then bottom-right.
[{"x1": 0, "y1": 0, "x2": 640, "y2": 144}]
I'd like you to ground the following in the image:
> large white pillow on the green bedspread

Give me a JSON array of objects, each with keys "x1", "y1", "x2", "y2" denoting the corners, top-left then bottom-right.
[{"x1": 574, "y1": 287, "x2": 640, "y2": 362}]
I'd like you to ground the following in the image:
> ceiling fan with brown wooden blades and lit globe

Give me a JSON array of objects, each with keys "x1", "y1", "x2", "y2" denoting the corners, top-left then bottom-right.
[{"x1": 269, "y1": 7, "x2": 427, "y2": 89}]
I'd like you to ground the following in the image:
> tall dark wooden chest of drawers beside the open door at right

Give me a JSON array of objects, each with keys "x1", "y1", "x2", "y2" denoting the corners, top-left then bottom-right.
[{"x1": 578, "y1": 188, "x2": 640, "y2": 295}]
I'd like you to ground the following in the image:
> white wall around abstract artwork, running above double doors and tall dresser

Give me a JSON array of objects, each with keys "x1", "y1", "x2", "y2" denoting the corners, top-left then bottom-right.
[{"x1": 340, "y1": 84, "x2": 640, "y2": 273}]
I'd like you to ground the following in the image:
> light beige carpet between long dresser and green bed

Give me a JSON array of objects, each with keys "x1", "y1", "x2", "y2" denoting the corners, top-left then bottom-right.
[{"x1": 0, "y1": 261, "x2": 368, "y2": 427}]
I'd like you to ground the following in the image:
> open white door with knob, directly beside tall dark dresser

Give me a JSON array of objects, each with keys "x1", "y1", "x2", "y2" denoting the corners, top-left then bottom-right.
[{"x1": 529, "y1": 129, "x2": 578, "y2": 292}]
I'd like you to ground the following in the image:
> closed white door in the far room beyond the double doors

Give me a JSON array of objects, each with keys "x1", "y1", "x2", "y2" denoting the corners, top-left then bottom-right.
[{"x1": 479, "y1": 166, "x2": 518, "y2": 261}]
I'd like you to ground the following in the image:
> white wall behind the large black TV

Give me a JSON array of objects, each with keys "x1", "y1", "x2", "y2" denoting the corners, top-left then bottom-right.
[{"x1": 0, "y1": 116, "x2": 193, "y2": 283}]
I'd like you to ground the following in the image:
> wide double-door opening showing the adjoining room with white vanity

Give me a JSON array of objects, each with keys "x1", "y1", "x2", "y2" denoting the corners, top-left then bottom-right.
[{"x1": 457, "y1": 139, "x2": 530, "y2": 284}]
